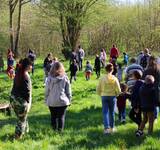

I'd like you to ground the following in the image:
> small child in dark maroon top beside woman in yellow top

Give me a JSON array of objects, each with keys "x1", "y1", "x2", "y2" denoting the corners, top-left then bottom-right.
[{"x1": 117, "y1": 83, "x2": 130, "y2": 123}]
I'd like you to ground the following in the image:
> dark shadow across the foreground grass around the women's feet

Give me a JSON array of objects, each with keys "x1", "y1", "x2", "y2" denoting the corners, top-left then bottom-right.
[{"x1": 0, "y1": 106, "x2": 159, "y2": 150}]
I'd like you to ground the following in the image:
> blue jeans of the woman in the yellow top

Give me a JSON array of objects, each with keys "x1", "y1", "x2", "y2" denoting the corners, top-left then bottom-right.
[{"x1": 102, "y1": 96, "x2": 116, "y2": 129}]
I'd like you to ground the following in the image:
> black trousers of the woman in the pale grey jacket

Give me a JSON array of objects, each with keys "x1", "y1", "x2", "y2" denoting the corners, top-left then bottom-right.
[{"x1": 49, "y1": 106, "x2": 67, "y2": 131}]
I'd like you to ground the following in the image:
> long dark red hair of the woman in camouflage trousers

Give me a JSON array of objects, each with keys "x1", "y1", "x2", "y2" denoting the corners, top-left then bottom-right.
[{"x1": 15, "y1": 58, "x2": 32, "y2": 86}]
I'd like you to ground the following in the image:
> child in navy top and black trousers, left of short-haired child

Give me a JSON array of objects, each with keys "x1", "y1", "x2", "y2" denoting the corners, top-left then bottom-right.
[{"x1": 129, "y1": 70, "x2": 143, "y2": 127}]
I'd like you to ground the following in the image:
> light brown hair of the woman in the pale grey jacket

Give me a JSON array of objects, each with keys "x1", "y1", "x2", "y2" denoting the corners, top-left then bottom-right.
[{"x1": 50, "y1": 62, "x2": 65, "y2": 77}]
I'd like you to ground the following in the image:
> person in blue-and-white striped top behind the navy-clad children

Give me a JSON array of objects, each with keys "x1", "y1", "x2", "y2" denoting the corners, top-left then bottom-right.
[{"x1": 125, "y1": 58, "x2": 143, "y2": 90}]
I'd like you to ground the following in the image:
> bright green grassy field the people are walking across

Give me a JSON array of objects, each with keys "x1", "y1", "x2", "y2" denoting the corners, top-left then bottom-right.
[{"x1": 0, "y1": 60, "x2": 160, "y2": 150}]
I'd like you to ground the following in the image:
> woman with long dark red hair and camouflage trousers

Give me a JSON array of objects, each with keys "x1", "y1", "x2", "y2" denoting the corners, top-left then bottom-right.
[{"x1": 10, "y1": 58, "x2": 32, "y2": 139}]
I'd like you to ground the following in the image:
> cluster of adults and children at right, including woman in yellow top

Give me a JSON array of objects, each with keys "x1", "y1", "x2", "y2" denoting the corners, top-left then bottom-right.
[{"x1": 97, "y1": 49, "x2": 160, "y2": 136}]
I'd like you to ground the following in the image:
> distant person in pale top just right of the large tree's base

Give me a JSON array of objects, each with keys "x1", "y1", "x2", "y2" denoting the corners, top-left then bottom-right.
[{"x1": 78, "y1": 45, "x2": 85, "y2": 70}]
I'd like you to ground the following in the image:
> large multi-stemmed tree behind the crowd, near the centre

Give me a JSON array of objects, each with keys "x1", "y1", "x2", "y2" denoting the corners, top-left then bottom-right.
[{"x1": 43, "y1": 0, "x2": 98, "y2": 58}]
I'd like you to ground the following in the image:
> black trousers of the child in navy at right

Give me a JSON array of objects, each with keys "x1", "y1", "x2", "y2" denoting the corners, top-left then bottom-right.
[{"x1": 129, "y1": 108, "x2": 142, "y2": 127}]
